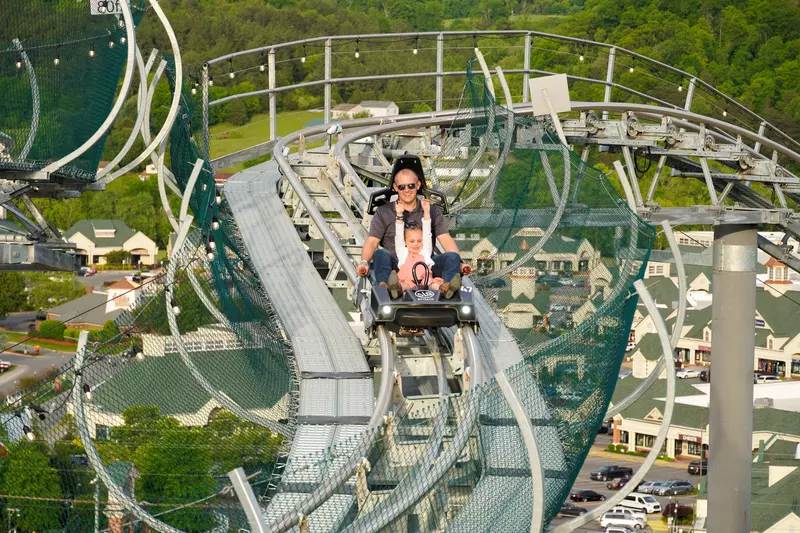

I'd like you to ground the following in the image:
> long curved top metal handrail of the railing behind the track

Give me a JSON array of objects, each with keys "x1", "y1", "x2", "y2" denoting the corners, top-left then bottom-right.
[{"x1": 205, "y1": 30, "x2": 800, "y2": 152}]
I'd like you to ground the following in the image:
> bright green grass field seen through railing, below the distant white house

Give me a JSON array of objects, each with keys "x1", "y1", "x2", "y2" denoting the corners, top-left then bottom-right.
[{"x1": 210, "y1": 111, "x2": 323, "y2": 159}]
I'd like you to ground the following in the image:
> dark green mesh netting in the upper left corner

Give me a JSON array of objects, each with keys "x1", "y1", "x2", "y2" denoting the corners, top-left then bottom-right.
[{"x1": 0, "y1": 0, "x2": 144, "y2": 181}]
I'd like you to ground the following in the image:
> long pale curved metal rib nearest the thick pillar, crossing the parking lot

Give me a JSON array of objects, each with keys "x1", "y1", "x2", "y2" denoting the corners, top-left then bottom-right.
[{"x1": 555, "y1": 279, "x2": 675, "y2": 533}]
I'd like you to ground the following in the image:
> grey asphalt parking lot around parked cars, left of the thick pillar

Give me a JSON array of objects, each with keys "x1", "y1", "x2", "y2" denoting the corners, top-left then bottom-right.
[{"x1": 551, "y1": 446, "x2": 700, "y2": 532}]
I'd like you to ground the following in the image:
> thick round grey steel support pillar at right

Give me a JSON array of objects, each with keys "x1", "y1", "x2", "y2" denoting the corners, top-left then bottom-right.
[{"x1": 708, "y1": 224, "x2": 758, "y2": 533}]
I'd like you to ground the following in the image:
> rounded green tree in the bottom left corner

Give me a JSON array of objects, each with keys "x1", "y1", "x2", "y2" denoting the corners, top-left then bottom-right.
[{"x1": 0, "y1": 442, "x2": 62, "y2": 531}]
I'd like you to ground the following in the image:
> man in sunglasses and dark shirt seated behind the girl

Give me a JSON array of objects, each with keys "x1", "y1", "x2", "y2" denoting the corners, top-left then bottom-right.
[{"x1": 356, "y1": 157, "x2": 468, "y2": 299}]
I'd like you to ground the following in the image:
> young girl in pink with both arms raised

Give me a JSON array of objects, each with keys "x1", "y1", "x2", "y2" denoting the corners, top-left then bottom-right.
[{"x1": 389, "y1": 200, "x2": 444, "y2": 291}]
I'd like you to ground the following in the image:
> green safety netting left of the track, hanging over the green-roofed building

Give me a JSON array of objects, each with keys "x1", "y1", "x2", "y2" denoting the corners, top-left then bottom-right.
[{"x1": 0, "y1": 58, "x2": 297, "y2": 533}]
